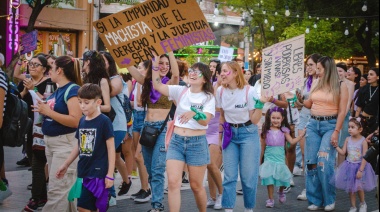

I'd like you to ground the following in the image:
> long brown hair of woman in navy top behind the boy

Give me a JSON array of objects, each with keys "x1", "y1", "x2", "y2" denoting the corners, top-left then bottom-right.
[{"x1": 55, "y1": 56, "x2": 82, "y2": 86}]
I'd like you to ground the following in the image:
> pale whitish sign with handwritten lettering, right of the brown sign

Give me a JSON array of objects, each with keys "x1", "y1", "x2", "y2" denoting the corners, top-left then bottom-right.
[{"x1": 261, "y1": 34, "x2": 305, "y2": 96}]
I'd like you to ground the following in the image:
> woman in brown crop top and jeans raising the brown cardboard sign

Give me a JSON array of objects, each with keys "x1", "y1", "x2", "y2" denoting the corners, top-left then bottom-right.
[{"x1": 128, "y1": 52, "x2": 182, "y2": 212}]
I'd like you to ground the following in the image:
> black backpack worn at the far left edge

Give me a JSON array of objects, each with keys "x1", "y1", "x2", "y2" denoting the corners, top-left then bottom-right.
[{"x1": 0, "y1": 74, "x2": 33, "y2": 147}]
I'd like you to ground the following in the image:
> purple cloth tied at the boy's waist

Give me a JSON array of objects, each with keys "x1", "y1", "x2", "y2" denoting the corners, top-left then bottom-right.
[{"x1": 83, "y1": 178, "x2": 108, "y2": 212}]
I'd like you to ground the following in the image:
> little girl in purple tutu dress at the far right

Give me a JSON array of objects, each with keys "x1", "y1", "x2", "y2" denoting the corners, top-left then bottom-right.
[{"x1": 331, "y1": 118, "x2": 376, "y2": 212}]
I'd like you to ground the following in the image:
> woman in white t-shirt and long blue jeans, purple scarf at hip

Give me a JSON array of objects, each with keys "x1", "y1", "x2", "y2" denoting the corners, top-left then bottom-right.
[{"x1": 216, "y1": 62, "x2": 264, "y2": 212}]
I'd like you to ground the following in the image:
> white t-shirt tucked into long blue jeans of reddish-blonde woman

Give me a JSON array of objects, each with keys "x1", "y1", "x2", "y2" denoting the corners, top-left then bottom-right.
[{"x1": 216, "y1": 85, "x2": 260, "y2": 124}]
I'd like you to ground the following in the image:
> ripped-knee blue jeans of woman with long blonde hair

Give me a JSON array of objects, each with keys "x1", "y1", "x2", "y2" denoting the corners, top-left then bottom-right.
[{"x1": 305, "y1": 119, "x2": 336, "y2": 206}]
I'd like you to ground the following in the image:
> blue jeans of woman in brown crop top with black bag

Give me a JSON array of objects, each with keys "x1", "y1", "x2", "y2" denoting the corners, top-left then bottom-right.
[{"x1": 141, "y1": 121, "x2": 166, "y2": 209}]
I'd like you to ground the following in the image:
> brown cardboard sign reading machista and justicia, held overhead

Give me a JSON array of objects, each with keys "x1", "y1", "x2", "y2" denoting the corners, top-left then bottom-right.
[{"x1": 93, "y1": 0, "x2": 215, "y2": 67}]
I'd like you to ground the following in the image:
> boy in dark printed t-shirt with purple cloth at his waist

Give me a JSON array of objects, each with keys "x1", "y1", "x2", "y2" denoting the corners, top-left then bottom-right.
[{"x1": 56, "y1": 83, "x2": 115, "y2": 212}]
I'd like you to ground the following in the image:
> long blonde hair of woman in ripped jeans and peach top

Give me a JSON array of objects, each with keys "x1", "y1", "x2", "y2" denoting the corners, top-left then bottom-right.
[{"x1": 310, "y1": 56, "x2": 340, "y2": 103}]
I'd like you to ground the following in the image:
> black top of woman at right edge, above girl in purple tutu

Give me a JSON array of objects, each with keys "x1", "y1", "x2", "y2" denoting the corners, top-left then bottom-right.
[{"x1": 356, "y1": 85, "x2": 379, "y2": 116}]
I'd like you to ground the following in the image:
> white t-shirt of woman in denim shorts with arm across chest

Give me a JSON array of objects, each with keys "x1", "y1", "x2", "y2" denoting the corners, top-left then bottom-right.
[{"x1": 168, "y1": 85, "x2": 215, "y2": 130}]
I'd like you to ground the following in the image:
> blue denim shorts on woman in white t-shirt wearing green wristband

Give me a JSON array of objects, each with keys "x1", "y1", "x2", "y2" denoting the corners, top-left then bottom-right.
[{"x1": 166, "y1": 133, "x2": 210, "y2": 166}]
